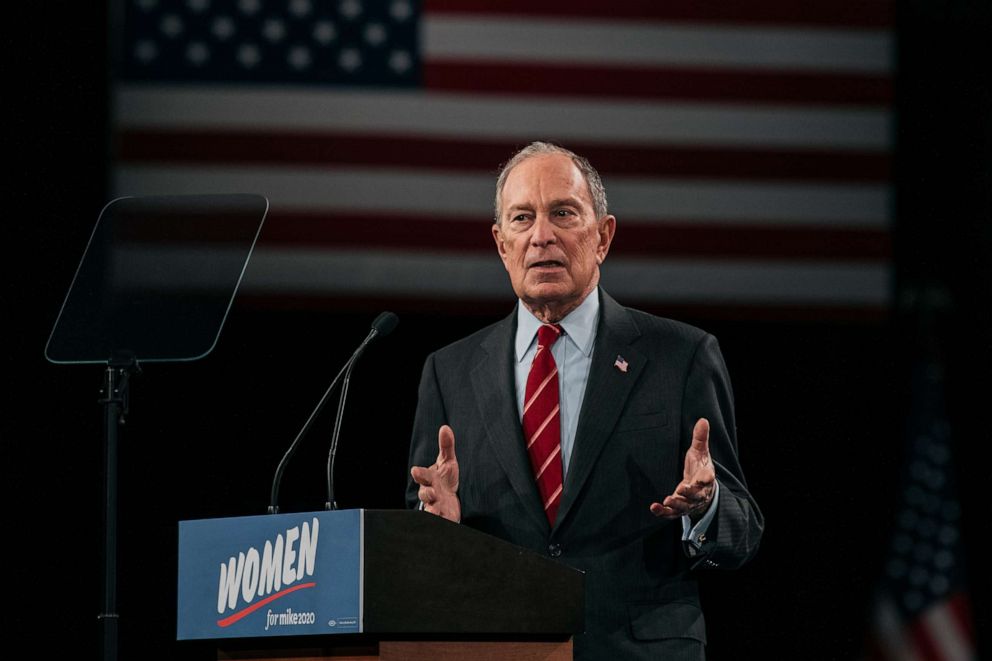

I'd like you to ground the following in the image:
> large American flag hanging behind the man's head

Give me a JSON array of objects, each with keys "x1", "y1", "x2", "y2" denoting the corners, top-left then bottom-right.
[{"x1": 113, "y1": 0, "x2": 893, "y2": 317}]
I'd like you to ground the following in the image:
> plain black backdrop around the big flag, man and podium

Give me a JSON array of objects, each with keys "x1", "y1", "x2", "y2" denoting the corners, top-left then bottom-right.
[{"x1": 0, "y1": 2, "x2": 992, "y2": 659}]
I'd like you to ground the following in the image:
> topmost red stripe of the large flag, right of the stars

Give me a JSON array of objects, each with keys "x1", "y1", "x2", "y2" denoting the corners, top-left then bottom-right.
[{"x1": 424, "y1": 0, "x2": 895, "y2": 28}]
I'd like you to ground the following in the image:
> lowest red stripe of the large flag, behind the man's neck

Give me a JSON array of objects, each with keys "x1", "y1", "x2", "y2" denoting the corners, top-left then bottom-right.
[{"x1": 234, "y1": 294, "x2": 889, "y2": 327}]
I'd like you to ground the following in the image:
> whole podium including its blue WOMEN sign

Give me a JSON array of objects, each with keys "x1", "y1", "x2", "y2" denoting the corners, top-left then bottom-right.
[{"x1": 177, "y1": 510, "x2": 584, "y2": 661}]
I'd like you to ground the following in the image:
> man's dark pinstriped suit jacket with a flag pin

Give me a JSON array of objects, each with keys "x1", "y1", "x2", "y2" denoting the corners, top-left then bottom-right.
[{"x1": 407, "y1": 291, "x2": 764, "y2": 659}]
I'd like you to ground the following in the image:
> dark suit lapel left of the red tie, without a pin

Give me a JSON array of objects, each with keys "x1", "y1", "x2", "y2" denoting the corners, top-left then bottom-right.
[{"x1": 471, "y1": 308, "x2": 548, "y2": 528}]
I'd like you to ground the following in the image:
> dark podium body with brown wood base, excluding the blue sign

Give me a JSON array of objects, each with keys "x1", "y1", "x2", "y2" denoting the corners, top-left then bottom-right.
[{"x1": 180, "y1": 510, "x2": 584, "y2": 661}]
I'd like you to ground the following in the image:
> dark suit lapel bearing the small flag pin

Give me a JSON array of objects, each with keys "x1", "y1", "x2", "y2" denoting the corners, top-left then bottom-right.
[{"x1": 555, "y1": 290, "x2": 647, "y2": 528}]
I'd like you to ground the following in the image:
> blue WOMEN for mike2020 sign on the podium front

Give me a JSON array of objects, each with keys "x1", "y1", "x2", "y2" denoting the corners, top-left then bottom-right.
[{"x1": 176, "y1": 510, "x2": 364, "y2": 640}]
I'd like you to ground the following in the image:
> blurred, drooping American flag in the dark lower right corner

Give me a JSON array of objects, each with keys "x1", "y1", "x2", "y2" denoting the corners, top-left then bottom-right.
[{"x1": 867, "y1": 363, "x2": 977, "y2": 661}]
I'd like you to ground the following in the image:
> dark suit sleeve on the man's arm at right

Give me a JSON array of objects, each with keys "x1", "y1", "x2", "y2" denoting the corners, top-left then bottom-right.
[{"x1": 681, "y1": 335, "x2": 764, "y2": 569}]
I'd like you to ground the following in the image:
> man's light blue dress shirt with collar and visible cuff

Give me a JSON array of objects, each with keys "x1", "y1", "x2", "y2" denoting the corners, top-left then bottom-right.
[{"x1": 514, "y1": 289, "x2": 720, "y2": 547}]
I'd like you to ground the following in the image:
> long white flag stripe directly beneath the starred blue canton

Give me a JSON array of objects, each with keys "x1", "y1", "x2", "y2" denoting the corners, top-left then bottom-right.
[{"x1": 116, "y1": 85, "x2": 892, "y2": 150}]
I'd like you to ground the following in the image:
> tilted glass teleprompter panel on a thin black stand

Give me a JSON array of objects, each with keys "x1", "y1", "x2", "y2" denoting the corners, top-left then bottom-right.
[{"x1": 45, "y1": 195, "x2": 268, "y2": 661}]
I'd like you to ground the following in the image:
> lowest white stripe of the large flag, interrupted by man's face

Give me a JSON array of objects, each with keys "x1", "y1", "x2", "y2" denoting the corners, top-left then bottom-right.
[{"x1": 234, "y1": 248, "x2": 891, "y2": 306}]
